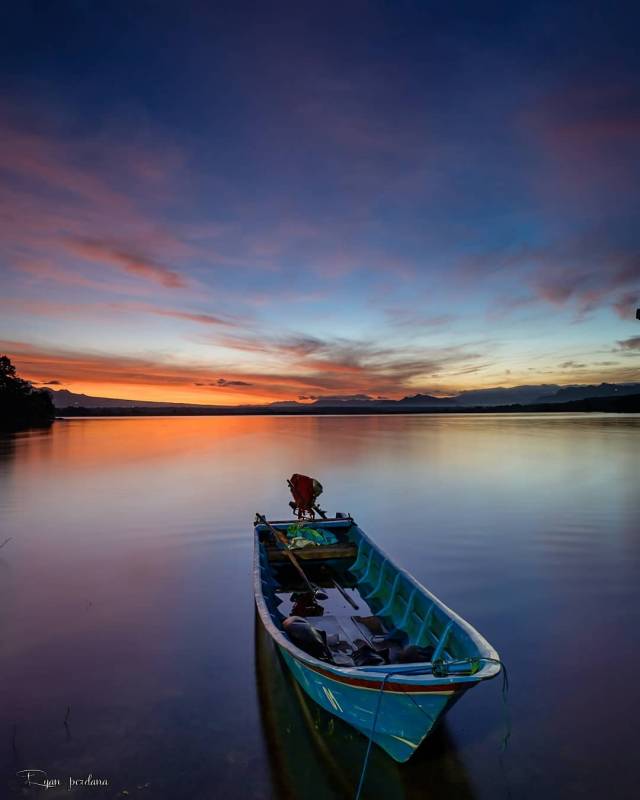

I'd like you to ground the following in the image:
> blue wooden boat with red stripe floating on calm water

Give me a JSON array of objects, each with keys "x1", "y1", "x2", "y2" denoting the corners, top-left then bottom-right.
[{"x1": 254, "y1": 515, "x2": 501, "y2": 762}]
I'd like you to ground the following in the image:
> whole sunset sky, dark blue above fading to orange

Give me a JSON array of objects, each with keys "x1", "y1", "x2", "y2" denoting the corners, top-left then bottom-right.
[{"x1": 0, "y1": 0, "x2": 640, "y2": 404}]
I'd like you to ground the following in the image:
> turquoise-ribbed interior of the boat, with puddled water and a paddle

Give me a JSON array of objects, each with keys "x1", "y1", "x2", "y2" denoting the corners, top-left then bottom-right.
[{"x1": 257, "y1": 518, "x2": 480, "y2": 674}]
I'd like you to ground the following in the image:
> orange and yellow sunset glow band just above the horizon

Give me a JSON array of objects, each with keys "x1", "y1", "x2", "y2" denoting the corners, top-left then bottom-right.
[{"x1": 6, "y1": 341, "x2": 638, "y2": 406}]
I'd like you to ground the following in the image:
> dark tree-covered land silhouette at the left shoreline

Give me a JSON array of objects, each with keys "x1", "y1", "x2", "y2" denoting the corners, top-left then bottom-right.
[{"x1": 0, "y1": 356, "x2": 55, "y2": 431}]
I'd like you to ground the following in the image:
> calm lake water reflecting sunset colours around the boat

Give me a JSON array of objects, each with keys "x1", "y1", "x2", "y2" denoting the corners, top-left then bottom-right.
[{"x1": 0, "y1": 414, "x2": 640, "y2": 800}]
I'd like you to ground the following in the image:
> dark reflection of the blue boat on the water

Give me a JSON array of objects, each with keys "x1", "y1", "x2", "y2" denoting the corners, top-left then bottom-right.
[{"x1": 254, "y1": 613, "x2": 475, "y2": 800}]
